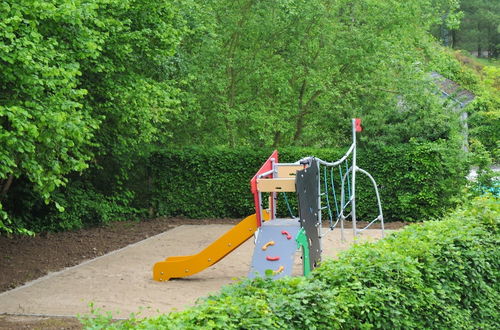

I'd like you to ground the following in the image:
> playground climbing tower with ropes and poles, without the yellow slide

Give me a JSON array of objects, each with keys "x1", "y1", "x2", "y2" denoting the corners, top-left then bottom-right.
[{"x1": 250, "y1": 119, "x2": 384, "y2": 277}]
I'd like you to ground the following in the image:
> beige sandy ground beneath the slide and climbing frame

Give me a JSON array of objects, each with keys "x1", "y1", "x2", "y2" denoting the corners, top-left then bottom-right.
[{"x1": 0, "y1": 225, "x2": 381, "y2": 318}]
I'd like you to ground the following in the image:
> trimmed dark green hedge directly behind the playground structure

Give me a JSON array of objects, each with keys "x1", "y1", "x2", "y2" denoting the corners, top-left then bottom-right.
[{"x1": 148, "y1": 142, "x2": 467, "y2": 221}]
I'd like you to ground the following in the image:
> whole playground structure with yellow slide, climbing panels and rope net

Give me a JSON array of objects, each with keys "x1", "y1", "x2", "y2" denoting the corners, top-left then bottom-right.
[{"x1": 153, "y1": 119, "x2": 384, "y2": 281}]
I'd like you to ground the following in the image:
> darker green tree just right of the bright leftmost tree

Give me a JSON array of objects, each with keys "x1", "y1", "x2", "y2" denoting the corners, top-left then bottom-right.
[{"x1": 74, "y1": 0, "x2": 190, "y2": 197}]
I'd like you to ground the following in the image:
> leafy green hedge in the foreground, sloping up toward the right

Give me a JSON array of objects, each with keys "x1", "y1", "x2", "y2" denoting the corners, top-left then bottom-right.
[{"x1": 82, "y1": 198, "x2": 500, "y2": 329}]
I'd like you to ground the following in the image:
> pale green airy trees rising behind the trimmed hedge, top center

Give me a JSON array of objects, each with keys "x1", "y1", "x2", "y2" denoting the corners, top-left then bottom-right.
[{"x1": 168, "y1": 0, "x2": 464, "y2": 146}]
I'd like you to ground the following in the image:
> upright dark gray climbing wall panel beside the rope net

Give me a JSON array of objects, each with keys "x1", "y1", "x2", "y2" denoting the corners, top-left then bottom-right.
[{"x1": 295, "y1": 158, "x2": 321, "y2": 270}]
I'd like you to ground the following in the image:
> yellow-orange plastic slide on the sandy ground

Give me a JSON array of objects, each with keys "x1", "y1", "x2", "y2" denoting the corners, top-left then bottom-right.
[{"x1": 153, "y1": 213, "x2": 267, "y2": 282}]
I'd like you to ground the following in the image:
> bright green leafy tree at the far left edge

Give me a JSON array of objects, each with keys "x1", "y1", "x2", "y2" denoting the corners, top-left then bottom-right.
[{"x1": 0, "y1": 0, "x2": 98, "y2": 230}]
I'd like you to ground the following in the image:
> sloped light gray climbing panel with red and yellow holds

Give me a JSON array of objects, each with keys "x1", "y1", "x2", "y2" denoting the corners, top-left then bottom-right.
[{"x1": 248, "y1": 219, "x2": 300, "y2": 279}]
